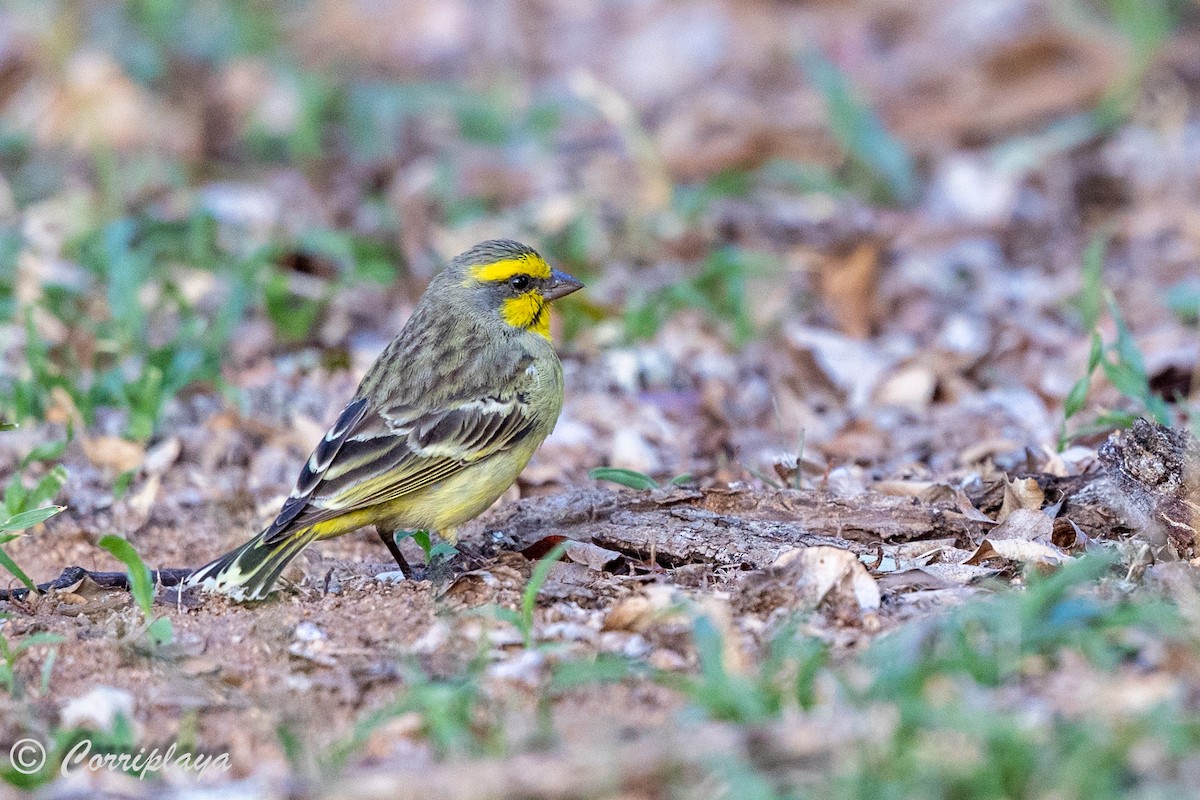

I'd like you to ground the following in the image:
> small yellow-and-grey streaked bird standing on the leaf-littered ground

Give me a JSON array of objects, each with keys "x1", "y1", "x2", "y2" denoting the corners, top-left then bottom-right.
[{"x1": 185, "y1": 240, "x2": 583, "y2": 600}]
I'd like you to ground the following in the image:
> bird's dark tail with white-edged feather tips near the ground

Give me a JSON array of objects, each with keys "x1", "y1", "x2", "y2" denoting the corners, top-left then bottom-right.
[{"x1": 185, "y1": 528, "x2": 317, "y2": 601}]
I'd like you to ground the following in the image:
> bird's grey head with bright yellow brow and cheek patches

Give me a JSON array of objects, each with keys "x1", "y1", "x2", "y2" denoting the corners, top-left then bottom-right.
[{"x1": 438, "y1": 239, "x2": 583, "y2": 339}]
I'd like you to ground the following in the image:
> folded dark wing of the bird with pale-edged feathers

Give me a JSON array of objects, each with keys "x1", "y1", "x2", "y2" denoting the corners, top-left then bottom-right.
[{"x1": 268, "y1": 381, "x2": 536, "y2": 542}]
